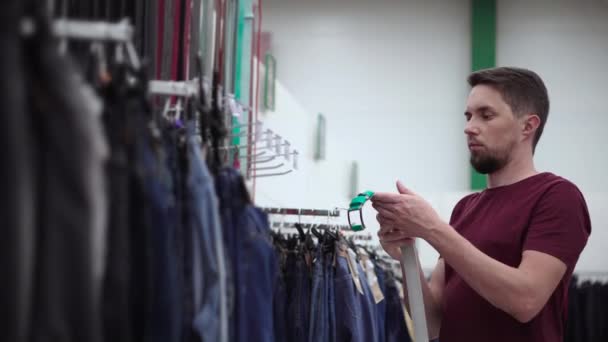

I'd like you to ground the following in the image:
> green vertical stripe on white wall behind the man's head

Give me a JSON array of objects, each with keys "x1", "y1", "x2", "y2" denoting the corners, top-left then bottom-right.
[{"x1": 471, "y1": 0, "x2": 496, "y2": 190}]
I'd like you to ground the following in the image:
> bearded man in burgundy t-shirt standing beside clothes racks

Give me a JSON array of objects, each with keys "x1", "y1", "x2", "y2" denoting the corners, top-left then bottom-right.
[{"x1": 372, "y1": 68, "x2": 591, "y2": 342}]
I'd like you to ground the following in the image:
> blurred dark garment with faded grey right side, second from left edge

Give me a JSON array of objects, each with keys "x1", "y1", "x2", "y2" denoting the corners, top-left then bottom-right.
[{"x1": 26, "y1": 16, "x2": 107, "y2": 341}]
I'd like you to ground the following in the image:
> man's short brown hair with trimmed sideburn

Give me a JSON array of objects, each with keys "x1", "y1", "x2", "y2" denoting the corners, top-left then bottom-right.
[{"x1": 467, "y1": 67, "x2": 549, "y2": 151}]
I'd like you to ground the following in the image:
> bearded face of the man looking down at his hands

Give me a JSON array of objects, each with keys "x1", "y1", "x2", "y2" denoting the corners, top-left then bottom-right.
[{"x1": 464, "y1": 85, "x2": 520, "y2": 174}]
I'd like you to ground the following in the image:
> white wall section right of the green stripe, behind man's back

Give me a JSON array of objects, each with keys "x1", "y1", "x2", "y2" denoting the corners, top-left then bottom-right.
[{"x1": 497, "y1": 0, "x2": 608, "y2": 271}]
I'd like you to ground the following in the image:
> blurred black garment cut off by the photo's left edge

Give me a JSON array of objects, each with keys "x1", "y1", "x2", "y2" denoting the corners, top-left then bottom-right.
[{"x1": 0, "y1": 0, "x2": 36, "y2": 342}]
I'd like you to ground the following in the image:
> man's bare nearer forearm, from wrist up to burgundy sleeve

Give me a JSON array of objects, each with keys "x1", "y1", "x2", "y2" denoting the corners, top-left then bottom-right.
[{"x1": 425, "y1": 223, "x2": 566, "y2": 323}]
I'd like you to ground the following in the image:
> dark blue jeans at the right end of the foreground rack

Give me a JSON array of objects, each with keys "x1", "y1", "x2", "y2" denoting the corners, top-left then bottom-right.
[{"x1": 216, "y1": 168, "x2": 278, "y2": 342}]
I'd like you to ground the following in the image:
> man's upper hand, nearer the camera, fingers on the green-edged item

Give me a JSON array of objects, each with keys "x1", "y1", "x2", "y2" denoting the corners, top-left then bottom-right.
[{"x1": 371, "y1": 181, "x2": 443, "y2": 240}]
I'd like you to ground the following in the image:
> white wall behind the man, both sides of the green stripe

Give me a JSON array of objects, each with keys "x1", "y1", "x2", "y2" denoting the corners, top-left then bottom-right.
[{"x1": 257, "y1": 0, "x2": 608, "y2": 271}]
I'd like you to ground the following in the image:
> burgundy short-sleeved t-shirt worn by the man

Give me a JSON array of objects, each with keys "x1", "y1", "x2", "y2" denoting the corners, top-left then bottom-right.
[{"x1": 439, "y1": 173, "x2": 591, "y2": 342}]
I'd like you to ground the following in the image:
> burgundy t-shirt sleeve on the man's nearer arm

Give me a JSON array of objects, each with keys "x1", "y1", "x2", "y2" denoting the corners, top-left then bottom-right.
[{"x1": 523, "y1": 182, "x2": 591, "y2": 268}]
